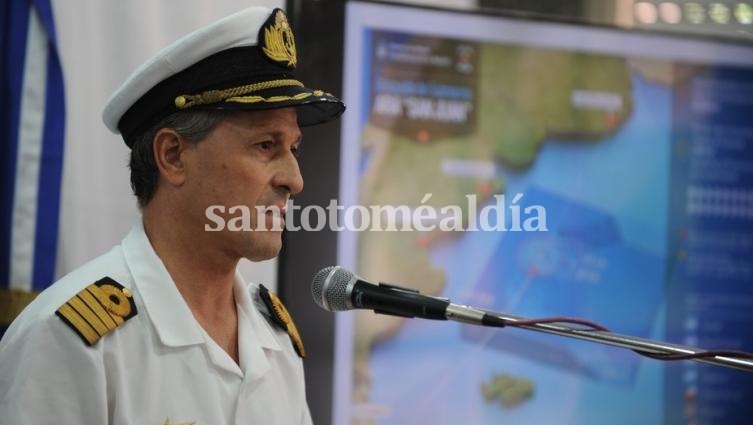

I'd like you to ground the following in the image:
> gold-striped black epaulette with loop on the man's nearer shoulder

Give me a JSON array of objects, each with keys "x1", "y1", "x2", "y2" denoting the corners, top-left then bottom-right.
[{"x1": 55, "y1": 277, "x2": 136, "y2": 346}]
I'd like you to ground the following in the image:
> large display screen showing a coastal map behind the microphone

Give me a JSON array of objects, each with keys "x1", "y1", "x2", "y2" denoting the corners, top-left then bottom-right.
[{"x1": 333, "y1": 2, "x2": 753, "y2": 425}]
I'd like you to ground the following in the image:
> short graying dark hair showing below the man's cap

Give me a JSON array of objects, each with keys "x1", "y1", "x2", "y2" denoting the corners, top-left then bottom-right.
[{"x1": 128, "y1": 110, "x2": 232, "y2": 208}]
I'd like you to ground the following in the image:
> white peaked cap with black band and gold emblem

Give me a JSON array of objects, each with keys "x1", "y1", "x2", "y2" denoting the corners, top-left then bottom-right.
[{"x1": 102, "y1": 7, "x2": 345, "y2": 147}]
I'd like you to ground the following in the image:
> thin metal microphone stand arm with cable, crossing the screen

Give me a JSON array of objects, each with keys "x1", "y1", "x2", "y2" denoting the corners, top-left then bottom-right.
[{"x1": 476, "y1": 310, "x2": 753, "y2": 372}]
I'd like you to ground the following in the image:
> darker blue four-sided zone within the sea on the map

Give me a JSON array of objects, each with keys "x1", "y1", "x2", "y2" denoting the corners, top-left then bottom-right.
[{"x1": 463, "y1": 187, "x2": 664, "y2": 384}]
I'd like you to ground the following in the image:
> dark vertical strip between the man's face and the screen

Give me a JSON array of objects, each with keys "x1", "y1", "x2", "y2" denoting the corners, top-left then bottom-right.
[{"x1": 278, "y1": 0, "x2": 347, "y2": 424}]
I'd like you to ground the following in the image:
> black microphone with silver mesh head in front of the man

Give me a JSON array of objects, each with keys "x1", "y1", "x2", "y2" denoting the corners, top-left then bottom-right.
[{"x1": 311, "y1": 266, "x2": 505, "y2": 327}]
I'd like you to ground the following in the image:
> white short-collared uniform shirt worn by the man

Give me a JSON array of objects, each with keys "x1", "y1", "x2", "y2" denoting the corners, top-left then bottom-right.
[{"x1": 0, "y1": 223, "x2": 311, "y2": 425}]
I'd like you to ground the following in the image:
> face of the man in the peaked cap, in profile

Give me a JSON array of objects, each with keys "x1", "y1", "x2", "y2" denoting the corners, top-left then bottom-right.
[{"x1": 184, "y1": 108, "x2": 303, "y2": 261}]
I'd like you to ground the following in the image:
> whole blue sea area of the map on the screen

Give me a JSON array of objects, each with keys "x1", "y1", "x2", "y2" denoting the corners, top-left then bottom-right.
[{"x1": 369, "y1": 75, "x2": 674, "y2": 425}]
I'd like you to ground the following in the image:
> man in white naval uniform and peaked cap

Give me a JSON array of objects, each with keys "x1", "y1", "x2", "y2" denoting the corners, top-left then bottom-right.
[{"x1": 0, "y1": 8, "x2": 344, "y2": 425}]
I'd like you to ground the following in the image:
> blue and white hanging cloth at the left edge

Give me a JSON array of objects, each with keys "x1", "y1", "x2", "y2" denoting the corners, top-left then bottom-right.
[{"x1": 0, "y1": 0, "x2": 65, "y2": 335}]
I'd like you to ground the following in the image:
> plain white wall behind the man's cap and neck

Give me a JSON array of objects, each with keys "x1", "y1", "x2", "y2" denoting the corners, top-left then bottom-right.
[{"x1": 52, "y1": 0, "x2": 285, "y2": 287}]
